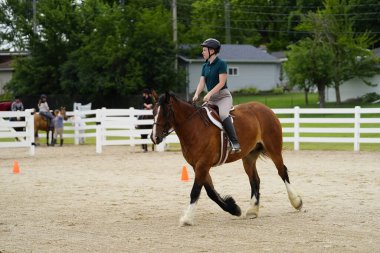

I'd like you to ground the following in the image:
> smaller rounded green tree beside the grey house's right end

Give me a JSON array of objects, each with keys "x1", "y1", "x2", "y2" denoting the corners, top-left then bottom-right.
[{"x1": 284, "y1": 38, "x2": 333, "y2": 108}]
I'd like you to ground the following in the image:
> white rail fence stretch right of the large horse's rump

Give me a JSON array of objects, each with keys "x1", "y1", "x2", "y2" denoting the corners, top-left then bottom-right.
[{"x1": 273, "y1": 106, "x2": 380, "y2": 151}]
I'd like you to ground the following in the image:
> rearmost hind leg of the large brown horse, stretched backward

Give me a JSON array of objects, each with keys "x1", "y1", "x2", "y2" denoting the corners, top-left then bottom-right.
[{"x1": 265, "y1": 140, "x2": 302, "y2": 210}]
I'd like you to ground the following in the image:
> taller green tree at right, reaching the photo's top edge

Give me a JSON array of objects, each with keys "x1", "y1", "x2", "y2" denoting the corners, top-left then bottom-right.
[{"x1": 298, "y1": 0, "x2": 380, "y2": 103}]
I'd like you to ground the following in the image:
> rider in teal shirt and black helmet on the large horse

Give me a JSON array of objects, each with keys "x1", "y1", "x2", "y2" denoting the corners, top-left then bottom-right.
[{"x1": 193, "y1": 38, "x2": 241, "y2": 153}]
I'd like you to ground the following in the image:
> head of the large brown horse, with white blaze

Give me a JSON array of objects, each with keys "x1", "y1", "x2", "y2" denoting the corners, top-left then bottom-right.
[{"x1": 150, "y1": 92, "x2": 177, "y2": 144}]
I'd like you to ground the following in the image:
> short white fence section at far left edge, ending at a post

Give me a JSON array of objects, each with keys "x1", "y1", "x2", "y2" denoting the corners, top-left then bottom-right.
[{"x1": 0, "y1": 110, "x2": 35, "y2": 155}]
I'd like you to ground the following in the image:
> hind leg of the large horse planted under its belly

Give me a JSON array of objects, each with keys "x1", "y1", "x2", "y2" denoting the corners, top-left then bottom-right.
[{"x1": 243, "y1": 150, "x2": 260, "y2": 218}]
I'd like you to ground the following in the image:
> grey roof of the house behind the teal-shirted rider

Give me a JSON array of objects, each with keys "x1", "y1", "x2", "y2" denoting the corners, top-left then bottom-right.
[{"x1": 180, "y1": 44, "x2": 280, "y2": 63}]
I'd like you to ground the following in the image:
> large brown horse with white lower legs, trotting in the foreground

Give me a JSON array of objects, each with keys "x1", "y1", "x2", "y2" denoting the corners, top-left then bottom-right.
[{"x1": 151, "y1": 92, "x2": 302, "y2": 225}]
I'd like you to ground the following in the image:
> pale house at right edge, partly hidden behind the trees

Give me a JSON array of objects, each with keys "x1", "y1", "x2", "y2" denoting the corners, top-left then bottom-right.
[{"x1": 326, "y1": 48, "x2": 380, "y2": 102}]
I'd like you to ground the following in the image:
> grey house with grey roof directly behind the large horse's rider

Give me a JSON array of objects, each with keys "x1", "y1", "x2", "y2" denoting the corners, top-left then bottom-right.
[{"x1": 178, "y1": 44, "x2": 281, "y2": 95}]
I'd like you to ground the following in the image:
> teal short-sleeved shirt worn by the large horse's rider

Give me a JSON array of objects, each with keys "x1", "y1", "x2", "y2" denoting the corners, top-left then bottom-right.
[{"x1": 202, "y1": 57, "x2": 227, "y2": 91}]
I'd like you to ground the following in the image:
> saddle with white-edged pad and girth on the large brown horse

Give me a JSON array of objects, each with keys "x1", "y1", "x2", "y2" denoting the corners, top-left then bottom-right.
[{"x1": 202, "y1": 104, "x2": 234, "y2": 167}]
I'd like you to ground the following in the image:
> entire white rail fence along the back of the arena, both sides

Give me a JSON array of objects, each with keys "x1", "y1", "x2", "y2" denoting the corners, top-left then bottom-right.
[{"x1": 0, "y1": 107, "x2": 380, "y2": 153}]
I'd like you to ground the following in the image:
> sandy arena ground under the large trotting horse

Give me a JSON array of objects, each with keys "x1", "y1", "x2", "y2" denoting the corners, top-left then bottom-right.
[{"x1": 0, "y1": 145, "x2": 380, "y2": 253}]
